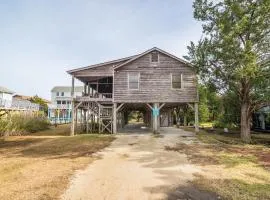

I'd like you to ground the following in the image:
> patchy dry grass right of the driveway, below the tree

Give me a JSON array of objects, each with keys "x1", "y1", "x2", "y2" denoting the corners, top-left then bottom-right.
[{"x1": 166, "y1": 128, "x2": 270, "y2": 200}]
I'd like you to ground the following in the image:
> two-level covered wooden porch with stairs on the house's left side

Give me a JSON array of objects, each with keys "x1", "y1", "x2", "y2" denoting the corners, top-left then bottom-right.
[{"x1": 71, "y1": 75, "x2": 113, "y2": 135}]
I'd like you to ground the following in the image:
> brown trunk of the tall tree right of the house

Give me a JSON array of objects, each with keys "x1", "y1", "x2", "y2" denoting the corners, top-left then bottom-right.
[{"x1": 241, "y1": 102, "x2": 251, "y2": 143}]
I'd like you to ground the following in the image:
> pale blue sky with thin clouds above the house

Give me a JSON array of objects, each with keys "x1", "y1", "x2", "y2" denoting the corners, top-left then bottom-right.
[{"x1": 0, "y1": 0, "x2": 201, "y2": 99}]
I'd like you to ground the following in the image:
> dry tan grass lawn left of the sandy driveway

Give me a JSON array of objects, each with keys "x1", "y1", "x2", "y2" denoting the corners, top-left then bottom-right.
[{"x1": 0, "y1": 126, "x2": 114, "y2": 200}]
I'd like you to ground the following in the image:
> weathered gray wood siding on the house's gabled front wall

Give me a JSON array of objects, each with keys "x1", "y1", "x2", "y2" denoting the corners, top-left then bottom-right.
[{"x1": 114, "y1": 53, "x2": 197, "y2": 103}]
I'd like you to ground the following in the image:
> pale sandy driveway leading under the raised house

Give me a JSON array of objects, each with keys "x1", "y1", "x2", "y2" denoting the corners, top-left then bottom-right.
[{"x1": 62, "y1": 128, "x2": 217, "y2": 200}]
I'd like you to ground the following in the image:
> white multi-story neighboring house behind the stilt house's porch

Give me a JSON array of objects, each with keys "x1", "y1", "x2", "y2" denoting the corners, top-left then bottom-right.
[{"x1": 48, "y1": 86, "x2": 83, "y2": 124}]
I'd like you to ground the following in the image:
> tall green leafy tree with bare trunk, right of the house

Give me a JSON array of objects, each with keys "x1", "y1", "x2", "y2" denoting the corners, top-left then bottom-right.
[{"x1": 186, "y1": 0, "x2": 270, "y2": 142}]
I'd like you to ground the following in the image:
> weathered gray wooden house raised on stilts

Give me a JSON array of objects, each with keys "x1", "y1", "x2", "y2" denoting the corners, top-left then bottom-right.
[{"x1": 68, "y1": 47, "x2": 199, "y2": 135}]
